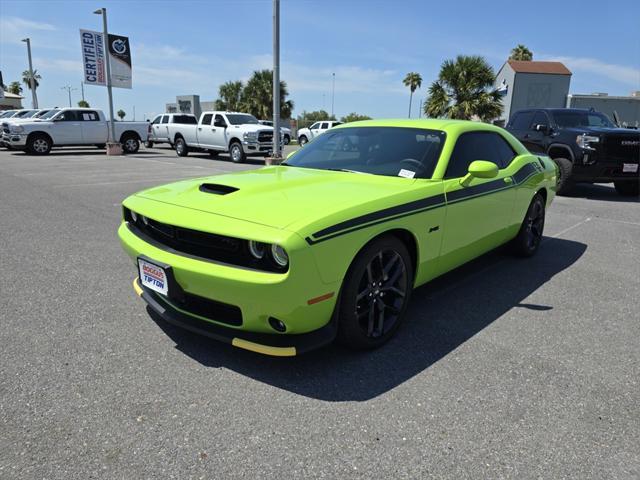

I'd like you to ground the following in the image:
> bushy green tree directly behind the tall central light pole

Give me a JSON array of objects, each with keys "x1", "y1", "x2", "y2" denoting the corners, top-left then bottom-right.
[{"x1": 240, "y1": 70, "x2": 293, "y2": 119}]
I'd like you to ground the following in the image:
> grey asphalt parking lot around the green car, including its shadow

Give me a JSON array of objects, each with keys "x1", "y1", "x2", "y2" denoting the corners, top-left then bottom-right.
[{"x1": 0, "y1": 144, "x2": 640, "y2": 479}]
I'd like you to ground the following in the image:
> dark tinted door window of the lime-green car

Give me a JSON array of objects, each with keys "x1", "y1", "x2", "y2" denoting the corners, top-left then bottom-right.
[{"x1": 445, "y1": 132, "x2": 515, "y2": 178}]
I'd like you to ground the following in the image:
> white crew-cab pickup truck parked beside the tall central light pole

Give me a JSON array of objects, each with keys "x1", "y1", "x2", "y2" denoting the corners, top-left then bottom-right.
[{"x1": 173, "y1": 112, "x2": 282, "y2": 163}]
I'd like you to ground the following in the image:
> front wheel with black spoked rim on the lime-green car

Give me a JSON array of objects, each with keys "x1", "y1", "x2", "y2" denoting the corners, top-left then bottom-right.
[{"x1": 336, "y1": 235, "x2": 413, "y2": 349}]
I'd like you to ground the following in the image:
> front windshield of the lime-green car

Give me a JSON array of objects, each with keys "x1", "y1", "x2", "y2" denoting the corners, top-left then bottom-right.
[{"x1": 285, "y1": 127, "x2": 446, "y2": 178}]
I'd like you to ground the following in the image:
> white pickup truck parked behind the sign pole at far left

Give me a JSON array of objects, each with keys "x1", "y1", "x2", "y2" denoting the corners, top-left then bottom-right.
[{"x1": 2, "y1": 108, "x2": 148, "y2": 155}]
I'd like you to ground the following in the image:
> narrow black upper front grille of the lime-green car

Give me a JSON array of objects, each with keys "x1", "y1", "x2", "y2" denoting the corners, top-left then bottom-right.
[{"x1": 124, "y1": 207, "x2": 288, "y2": 273}]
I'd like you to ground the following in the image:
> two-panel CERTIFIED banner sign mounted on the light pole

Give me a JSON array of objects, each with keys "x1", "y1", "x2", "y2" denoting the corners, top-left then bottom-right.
[{"x1": 80, "y1": 29, "x2": 131, "y2": 88}]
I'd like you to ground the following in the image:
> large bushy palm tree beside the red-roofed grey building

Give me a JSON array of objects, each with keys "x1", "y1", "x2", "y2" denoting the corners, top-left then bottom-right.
[{"x1": 424, "y1": 55, "x2": 502, "y2": 121}]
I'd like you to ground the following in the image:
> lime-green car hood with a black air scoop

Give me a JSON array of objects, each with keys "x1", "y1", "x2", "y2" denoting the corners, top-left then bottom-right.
[{"x1": 137, "y1": 166, "x2": 415, "y2": 229}]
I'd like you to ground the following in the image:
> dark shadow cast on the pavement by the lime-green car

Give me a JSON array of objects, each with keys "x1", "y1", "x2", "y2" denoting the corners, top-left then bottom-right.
[{"x1": 148, "y1": 238, "x2": 587, "y2": 402}]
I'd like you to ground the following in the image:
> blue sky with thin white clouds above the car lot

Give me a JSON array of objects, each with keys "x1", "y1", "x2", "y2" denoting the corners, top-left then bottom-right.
[{"x1": 0, "y1": 0, "x2": 640, "y2": 119}]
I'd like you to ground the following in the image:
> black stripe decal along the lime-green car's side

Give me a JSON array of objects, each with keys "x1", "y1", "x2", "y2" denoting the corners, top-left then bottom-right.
[{"x1": 305, "y1": 163, "x2": 540, "y2": 245}]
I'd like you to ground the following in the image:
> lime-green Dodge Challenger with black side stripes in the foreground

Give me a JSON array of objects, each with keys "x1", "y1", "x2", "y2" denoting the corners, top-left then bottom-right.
[{"x1": 118, "y1": 120, "x2": 557, "y2": 356}]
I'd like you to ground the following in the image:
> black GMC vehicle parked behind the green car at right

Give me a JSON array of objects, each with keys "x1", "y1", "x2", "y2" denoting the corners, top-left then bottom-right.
[{"x1": 506, "y1": 108, "x2": 640, "y2": 196}]
